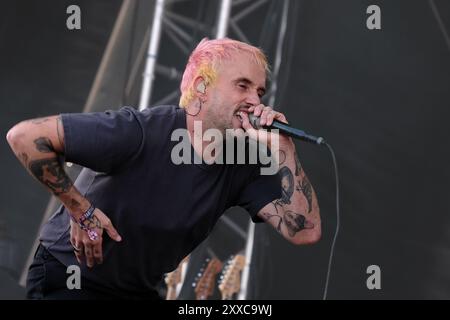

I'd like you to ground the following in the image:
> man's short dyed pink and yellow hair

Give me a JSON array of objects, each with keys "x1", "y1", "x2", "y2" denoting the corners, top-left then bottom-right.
[{"x1": 180, "y1": 38, "x2": 270, "y2": 108}]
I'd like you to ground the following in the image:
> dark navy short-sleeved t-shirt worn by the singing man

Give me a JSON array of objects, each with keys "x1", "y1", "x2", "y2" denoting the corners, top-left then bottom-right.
[{"x1": 41, "y1": 106, "x2": 281, "y2": 293}]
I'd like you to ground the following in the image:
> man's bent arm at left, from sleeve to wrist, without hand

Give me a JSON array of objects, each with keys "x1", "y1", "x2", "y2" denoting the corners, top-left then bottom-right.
[{"x1": 6, "y1": 116, "x2": 90, "y2": 218}]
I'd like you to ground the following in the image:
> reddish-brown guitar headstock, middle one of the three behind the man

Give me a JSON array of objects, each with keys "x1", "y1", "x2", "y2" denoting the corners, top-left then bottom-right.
[{"x1": 193, "y1": 257, "x2": 223, "y2": 300}]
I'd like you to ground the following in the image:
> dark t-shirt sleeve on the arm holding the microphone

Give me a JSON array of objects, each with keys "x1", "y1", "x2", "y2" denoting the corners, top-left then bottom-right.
[{"x1": 238, "y1": 167, "x2": 281, "y2": 222}]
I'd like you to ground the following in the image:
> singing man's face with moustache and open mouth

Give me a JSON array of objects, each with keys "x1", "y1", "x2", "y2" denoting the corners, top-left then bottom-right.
[{"x1": 204, "y1": 53, "x2": 266, "y2": 133}]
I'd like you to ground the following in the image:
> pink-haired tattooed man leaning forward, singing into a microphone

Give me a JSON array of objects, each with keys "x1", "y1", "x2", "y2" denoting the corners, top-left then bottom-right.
[{"x1": 7, "y1": 39, "x2": 321, "y2": 299}]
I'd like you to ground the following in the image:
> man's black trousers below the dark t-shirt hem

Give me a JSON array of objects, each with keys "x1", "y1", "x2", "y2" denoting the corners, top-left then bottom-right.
[{"x1": 26, "y1": 245, "x2": 161, "y2": 300}]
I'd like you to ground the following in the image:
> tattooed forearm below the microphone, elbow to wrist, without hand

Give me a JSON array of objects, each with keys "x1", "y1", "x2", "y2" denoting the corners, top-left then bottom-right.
[{"x1": 258, "y1": 139, "x2": 321, "y2": 244}]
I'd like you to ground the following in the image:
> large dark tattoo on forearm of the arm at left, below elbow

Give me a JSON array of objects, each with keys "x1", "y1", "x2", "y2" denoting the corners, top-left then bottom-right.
[{"x1": 29, "y1": 158, "x2": 73, "y2": 195}]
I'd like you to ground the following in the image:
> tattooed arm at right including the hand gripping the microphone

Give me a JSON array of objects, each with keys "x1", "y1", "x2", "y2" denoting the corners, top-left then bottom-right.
[{"x1": 241, "y1": 104, "x2": 321, "y2": 244}]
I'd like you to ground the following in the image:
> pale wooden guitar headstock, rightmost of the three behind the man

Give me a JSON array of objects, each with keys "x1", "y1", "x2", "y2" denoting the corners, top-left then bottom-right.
[{"x1": 219, "y1": 254, "x2": 245, "y2": 300}]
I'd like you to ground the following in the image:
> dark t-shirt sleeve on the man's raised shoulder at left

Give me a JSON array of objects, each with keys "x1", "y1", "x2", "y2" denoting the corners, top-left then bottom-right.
[{"x1": 61, "y1": 107, "x2": 144, "y2": 173}]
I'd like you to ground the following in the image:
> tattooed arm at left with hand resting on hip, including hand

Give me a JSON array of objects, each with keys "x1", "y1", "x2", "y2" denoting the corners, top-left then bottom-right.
[{"x1": 6, "y1": 116, "x2": 120, "y2": 267}]
